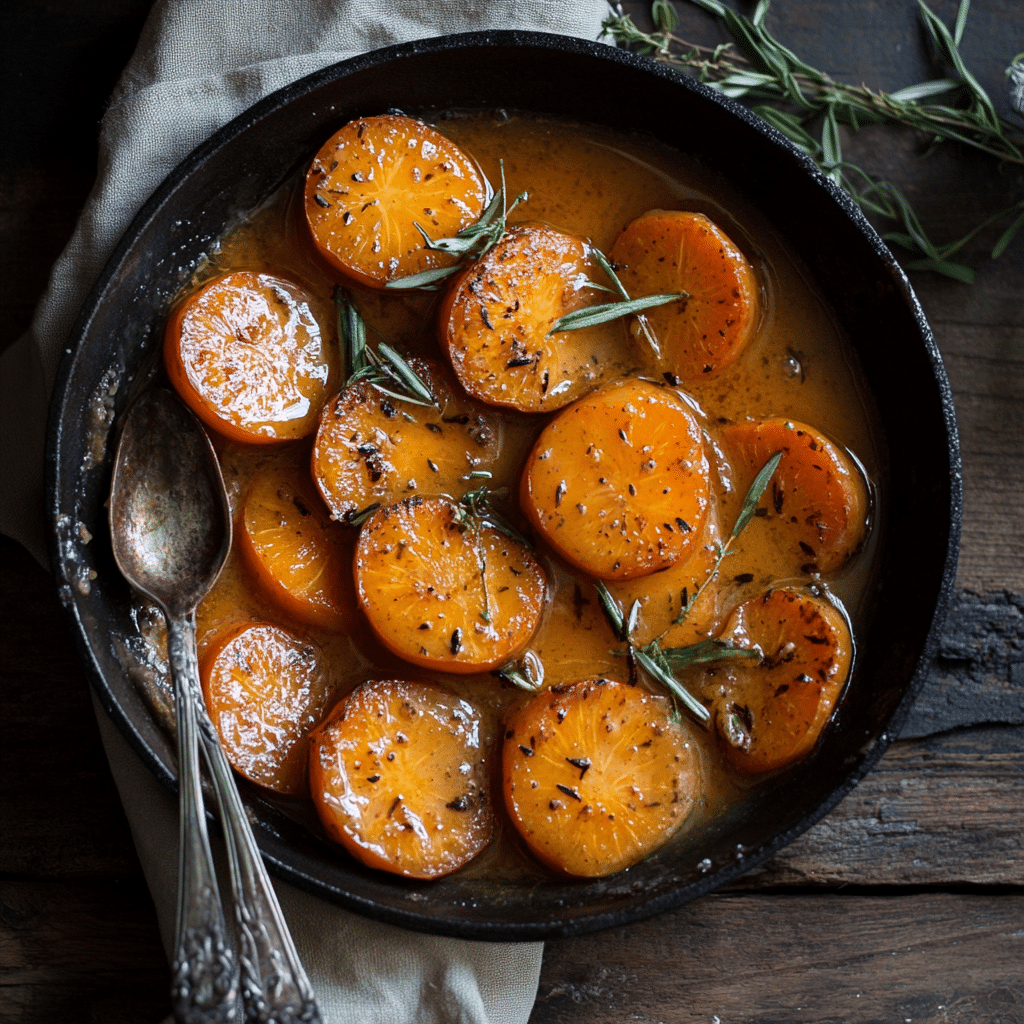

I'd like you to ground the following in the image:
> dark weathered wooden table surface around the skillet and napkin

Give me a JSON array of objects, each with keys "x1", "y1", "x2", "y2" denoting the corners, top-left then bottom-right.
[{"x1": 0, "y1": 0, "x2": 1024, "y2": 1024}]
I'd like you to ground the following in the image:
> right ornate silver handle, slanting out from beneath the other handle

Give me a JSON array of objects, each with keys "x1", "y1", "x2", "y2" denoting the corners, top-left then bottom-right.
[{"x1": 192, "y1": 679, "x2": 321, "y2": 1024}]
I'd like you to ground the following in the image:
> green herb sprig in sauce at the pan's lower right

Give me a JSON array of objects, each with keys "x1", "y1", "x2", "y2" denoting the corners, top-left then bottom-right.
[{"x1": 594, "y1": 452, "x2": 782, "y2": 725}]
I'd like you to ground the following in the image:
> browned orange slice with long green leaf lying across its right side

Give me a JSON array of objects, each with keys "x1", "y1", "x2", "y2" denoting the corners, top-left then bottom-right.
[{"x1": 439, "y1": 226, "x2": 626, "y2": 413}]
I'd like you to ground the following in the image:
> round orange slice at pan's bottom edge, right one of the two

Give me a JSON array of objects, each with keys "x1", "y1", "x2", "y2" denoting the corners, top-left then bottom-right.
[{"x1": 502, "y1": 679, "x2": 700, "y2": 878}]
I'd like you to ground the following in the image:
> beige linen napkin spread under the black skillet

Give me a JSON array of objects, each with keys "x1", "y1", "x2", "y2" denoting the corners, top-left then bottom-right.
[{"x1": 0, "y1": 0, "x2": 607, "y2": 1024}]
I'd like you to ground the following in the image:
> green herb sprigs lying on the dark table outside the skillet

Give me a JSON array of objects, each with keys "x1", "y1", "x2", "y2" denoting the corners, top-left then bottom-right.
[{"x1": 604, "y1": 0, "x2": 1024, "y2": 283}]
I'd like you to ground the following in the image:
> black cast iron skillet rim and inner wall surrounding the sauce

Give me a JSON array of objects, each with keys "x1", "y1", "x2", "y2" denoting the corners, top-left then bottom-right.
[{"x1": 47, "y1": 32, "x2": 962, "y2": 940}]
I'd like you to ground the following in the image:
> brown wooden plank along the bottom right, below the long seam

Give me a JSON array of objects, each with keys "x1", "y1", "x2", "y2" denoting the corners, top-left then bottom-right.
[{"x1": 530, "y1": 894, "x2": 1024, "y2": 1024}]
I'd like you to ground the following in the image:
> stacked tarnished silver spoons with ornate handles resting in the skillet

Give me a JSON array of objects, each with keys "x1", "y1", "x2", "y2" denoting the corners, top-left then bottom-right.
[{"x1": 110, "y1": 388, "x2": 321, "y2": 1024}]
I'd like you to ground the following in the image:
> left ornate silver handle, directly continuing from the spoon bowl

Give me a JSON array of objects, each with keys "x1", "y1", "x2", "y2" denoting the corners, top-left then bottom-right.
[{"x1": 167, "y1": 615, "x2": 239, "y2": 1024}]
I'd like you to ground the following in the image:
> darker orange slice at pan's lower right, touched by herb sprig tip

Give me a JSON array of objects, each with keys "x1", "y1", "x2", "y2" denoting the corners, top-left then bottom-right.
[{"x1": 702, "y1": 588, "x2": 853, "y2": 774}]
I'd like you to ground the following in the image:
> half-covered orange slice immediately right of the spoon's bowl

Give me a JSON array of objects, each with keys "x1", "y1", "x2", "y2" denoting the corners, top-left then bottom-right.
[{"x1": 238, "y1": 466, "x2": 355, "y2": 632}]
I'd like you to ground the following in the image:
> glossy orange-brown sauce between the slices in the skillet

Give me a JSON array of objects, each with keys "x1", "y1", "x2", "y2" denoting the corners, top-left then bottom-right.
[{"x1": 176, "y1": 115, "x2": 881, "y2": 877}]
